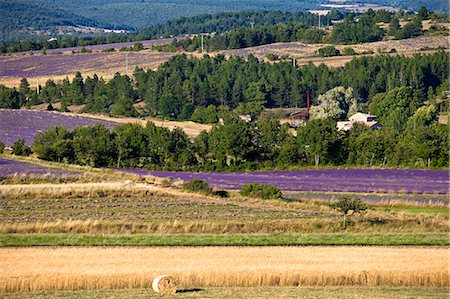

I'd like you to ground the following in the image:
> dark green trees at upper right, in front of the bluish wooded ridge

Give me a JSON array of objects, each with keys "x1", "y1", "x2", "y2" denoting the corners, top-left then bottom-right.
[{"x1": 154, "y1": 7, "x2": 440, "y2": 52}]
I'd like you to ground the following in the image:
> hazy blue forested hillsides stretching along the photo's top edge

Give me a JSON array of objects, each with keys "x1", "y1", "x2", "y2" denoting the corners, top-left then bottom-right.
[{"x1": 0, "y1": 0, "x2": 448, "y2": 43}]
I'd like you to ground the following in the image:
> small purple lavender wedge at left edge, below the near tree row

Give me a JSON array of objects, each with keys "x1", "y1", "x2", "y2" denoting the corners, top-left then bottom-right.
[{"x1": 0, "y1": 158, "x2": 80, "y2": 179}]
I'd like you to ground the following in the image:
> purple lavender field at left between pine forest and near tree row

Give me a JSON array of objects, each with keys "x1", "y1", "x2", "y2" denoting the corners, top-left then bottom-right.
[{"x1": 0, "y1": 109, "x2": 118, "y2": 147}]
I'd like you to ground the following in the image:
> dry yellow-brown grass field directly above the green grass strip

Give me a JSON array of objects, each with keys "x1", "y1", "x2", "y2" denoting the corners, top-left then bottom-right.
[{"x1": 0, "y1": 178, "x2": 449, "y2": 234}]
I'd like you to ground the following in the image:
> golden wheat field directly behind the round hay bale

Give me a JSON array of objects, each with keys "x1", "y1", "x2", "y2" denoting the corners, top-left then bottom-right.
[{"x1": 0, "y1": 246, "x2": 449, "y2": 292}]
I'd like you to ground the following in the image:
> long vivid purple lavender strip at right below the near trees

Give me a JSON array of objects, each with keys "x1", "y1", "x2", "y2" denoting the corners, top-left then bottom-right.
[{"x1": 123, "y1": 169, "x2": 449, "y2": 194}]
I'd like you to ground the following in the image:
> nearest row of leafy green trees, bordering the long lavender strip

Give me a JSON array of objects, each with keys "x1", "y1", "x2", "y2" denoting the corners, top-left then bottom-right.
[{"x1": 22, "y1": 98, "x2": 448, "y2": 171}]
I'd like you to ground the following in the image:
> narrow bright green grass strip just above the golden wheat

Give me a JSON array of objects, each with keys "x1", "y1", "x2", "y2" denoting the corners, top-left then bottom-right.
[{"x1": 0, "y1": 234, "x2": 449, "y2": 247}]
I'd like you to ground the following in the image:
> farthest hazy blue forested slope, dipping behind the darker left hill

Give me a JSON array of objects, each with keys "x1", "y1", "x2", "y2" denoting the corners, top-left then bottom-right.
[{"x1": 22, "y1": 0, "x2": 449, "y2": 29}]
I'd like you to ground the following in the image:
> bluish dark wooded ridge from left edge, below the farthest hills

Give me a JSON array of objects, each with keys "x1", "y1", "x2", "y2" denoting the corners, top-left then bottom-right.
[{"x1": 0, "y1": 10, "x2": 329, "y2": 53}]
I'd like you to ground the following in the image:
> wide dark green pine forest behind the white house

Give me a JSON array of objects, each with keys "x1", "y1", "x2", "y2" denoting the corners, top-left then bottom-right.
[{"x1": 0, "y1": 51, "x2": 449, "y2": 120}]
